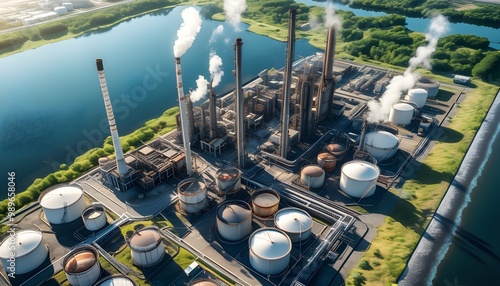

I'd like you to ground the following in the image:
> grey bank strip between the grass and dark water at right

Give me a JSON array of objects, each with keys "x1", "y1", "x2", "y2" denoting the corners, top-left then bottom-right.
[{"x1": 398, "y1": 86, "x2": 500, "y2": 285}]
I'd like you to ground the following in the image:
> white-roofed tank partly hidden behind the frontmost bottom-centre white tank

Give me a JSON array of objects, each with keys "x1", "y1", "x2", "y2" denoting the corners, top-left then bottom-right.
[{"x1": 274, "y1": 207, "x2": 312, "y2": 243}]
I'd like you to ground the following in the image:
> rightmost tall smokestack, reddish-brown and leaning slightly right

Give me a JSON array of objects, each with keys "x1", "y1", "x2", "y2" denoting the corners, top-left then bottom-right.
[{"x1": 316, "y1": 25, "x2": 337, "y2": 122}]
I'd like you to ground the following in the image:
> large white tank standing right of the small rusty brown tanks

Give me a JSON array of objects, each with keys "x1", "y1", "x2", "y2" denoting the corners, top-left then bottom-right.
[{"x1": 339, "y1": 160, "x2": 380, "y2": 198}]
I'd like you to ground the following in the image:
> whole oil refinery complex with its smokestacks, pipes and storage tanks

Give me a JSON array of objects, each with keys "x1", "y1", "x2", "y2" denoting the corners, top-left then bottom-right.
[{"x1": 0, "y1": 5, "x2": 466, "y2": 286}]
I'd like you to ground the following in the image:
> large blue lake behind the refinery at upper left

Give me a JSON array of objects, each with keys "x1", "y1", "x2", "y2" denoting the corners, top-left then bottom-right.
[{"x1": 0, "y1": 7, "x2": 318, "y2": 194}]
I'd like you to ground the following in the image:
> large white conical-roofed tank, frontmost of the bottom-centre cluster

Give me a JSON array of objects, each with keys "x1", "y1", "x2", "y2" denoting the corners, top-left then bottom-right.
[{"x1": 248, "y1": 227, "x2": 292, "y2": 275}]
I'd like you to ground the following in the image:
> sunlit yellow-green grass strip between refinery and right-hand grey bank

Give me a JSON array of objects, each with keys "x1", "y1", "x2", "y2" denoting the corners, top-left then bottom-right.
[{"x1": 347, "y1": 81, "x2": 498, "y2": 285}]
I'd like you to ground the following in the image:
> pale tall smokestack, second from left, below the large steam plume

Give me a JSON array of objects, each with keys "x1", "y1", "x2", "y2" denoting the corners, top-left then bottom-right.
[{"x1": 175, "y1": 57, "x2": 193, "y2": 176}]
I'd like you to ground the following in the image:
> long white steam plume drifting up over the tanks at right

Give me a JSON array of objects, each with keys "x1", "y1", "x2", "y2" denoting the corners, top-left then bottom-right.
[{"x1": 367, "y1": 15, "x2": 449, "y2": 122}]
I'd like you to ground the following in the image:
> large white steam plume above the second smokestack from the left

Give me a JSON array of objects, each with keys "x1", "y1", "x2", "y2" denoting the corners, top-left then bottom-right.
[{"x1": 174, "y1": 7, "x2": 201, "y2": 58}]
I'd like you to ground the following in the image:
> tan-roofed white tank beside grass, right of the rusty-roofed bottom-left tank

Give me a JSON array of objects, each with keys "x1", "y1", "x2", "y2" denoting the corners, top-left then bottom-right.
[{"x1": 129, "y1": 227, "x2": 165, "y2": 267}]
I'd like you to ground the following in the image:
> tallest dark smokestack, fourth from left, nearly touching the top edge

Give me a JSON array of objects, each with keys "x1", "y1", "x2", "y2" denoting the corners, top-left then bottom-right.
[{"x1": 280, "y1": 8, "x2": 297, "y2": 159}]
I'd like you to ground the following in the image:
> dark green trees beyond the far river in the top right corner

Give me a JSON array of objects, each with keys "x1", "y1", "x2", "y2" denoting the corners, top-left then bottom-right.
[{"x1": 341, "y1": 0, "x2": 500, "y2": 27}]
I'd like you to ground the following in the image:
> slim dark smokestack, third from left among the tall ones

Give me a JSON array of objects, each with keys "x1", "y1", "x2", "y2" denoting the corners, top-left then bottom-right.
[{"x1": 234, "y1": 38, "x2": 245, "y2": 168}]
